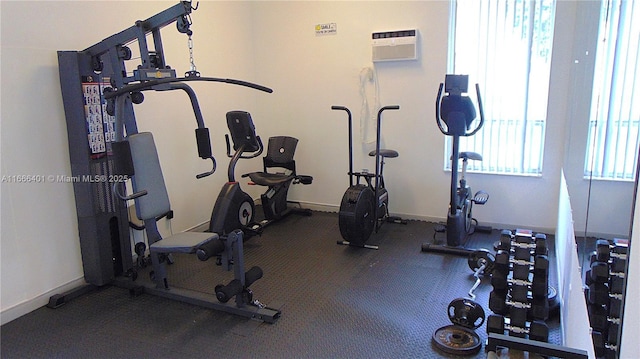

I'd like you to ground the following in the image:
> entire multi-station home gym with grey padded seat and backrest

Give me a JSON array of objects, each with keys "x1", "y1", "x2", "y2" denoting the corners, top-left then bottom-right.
[{"x1": 53, "y1": 1, "x2": 280, "y2": 323}]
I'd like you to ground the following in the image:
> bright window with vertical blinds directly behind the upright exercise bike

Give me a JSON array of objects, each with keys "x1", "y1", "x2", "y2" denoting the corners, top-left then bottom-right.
[{"x1": 445, "y1": 0, "x2": 555, "y2": 176}]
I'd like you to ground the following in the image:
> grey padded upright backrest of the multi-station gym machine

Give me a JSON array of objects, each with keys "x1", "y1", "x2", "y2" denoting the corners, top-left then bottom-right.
[{"x1": 127, "y1": 132, "x2": 171, "y2": 220}]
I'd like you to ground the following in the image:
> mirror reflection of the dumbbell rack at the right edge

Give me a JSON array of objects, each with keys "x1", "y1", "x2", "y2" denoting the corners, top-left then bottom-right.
[{"x1": 584, "y1": 239, "x2": 629, "y2": 359}]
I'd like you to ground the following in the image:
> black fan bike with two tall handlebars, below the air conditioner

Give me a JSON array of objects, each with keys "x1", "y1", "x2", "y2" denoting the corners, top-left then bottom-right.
[{"x1": 331, "y1": 105, "x2": 407, "y2": 249}]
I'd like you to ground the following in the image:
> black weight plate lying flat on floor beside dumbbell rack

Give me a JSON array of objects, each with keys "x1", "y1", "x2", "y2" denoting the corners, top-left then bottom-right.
[{"x1": 432, "y1": 325, "x2": 482, "y2": 355}]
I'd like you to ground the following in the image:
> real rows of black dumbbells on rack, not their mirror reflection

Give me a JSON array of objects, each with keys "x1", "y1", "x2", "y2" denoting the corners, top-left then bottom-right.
[{"x1": 487, "y1": 229, "x2": 549, "y2": 342}]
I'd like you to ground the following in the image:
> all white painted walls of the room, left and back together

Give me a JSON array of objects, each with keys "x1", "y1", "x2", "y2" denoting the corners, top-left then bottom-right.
[{"x1": 0, "y1": 1, "x2": 631, "y2": 344}]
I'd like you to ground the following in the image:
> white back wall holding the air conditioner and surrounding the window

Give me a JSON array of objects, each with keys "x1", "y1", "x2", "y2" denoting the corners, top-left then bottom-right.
[{"x1": 254, "y1": 1, "x2": 580, "y2": 236}]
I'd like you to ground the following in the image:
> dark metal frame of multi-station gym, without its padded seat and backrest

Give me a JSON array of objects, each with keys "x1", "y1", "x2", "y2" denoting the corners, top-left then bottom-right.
[{"x1": 55, "y1": 1, "x2": 280, "y2": 323}]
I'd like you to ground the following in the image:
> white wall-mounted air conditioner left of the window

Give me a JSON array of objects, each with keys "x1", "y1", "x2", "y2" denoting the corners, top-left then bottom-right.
[{"x1": 371, "y1": 29, "x2": 418, "y2": 62}]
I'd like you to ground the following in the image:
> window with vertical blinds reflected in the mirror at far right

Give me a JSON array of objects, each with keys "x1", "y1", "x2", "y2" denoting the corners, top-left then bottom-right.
[{"x1": 584, "y1": 0, "x2": 640, "y2": 181}]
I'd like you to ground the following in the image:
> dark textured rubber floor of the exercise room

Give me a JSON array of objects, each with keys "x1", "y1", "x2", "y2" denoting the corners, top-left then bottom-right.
[{"x1": 0, "y1": 212, "x2": 559, "y2": 359}]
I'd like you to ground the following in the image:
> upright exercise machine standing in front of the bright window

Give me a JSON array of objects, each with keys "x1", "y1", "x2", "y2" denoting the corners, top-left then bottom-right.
[{"x1": 422, "y1": 75, "x2": 491, "y2": 256}]
